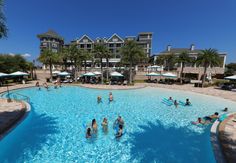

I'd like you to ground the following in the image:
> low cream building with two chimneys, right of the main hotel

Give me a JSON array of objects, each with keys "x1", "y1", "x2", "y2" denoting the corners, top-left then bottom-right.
[{"x1": 152, "y1": 44, "x2": 227, "y2": 80}]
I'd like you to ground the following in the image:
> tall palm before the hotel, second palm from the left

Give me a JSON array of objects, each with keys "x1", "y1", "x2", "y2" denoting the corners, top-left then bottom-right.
[{"x1": 68, "y1": 44, "x2": 82, "y2": 82}]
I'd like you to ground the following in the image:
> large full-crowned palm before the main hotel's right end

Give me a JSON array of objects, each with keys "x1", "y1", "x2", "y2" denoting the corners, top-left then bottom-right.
[{"x1": 121, "y1": 40, "x2": 145, "y2": 84}]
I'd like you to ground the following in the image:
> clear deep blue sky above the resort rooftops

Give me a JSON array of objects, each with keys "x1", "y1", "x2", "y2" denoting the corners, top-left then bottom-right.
[{"x1": 0, "y1": 0, "x2": 236, "y2": 63}]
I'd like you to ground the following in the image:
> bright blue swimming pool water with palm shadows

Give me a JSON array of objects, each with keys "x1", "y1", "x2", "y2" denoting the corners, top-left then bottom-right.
[{"x1": 0, "y1": 86, "x2": 236, "y2": 163}]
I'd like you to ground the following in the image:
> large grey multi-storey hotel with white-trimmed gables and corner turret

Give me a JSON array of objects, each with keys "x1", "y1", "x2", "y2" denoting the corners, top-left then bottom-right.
[{"x1": 38, "y1": 30, "x2": 152, "y2": 68}]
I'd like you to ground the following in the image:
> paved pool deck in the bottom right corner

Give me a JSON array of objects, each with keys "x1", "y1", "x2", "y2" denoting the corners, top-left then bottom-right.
[{"x1": 219, "y1": 114, "x2": 236, "y2": 163}]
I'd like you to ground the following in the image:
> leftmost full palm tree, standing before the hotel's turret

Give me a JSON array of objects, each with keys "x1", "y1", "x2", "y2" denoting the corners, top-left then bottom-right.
[{"x1": 38, "y1": 48, "x2": 58, "y2": 81}]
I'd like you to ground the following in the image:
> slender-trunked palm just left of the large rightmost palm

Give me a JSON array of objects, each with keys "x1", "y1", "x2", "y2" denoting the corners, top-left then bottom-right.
[{"x1": 176, "y1": 51, "x2": 192, "y2": 84}]
